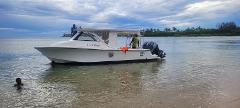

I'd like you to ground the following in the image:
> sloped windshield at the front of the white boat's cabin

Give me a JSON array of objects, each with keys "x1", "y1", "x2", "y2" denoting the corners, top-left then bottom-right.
[{"x1": 74, "y1": 32, "x2": 99, "y2": 41}]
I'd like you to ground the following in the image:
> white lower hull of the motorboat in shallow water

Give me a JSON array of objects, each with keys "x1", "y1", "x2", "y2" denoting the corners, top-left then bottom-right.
[{"x1": 36, "y1": 47, "x2": 161, "y2": 63}]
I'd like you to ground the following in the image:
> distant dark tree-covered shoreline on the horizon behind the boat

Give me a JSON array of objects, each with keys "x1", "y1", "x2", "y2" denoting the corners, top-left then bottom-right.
[{"x1": 141, "y1": 22, "x2": 240, "y2": 37}]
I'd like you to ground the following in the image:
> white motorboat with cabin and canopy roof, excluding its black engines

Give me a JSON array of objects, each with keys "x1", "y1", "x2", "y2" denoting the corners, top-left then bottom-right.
[{"x1": 35, "y1": 28, "x2": 165, "y2": 63}]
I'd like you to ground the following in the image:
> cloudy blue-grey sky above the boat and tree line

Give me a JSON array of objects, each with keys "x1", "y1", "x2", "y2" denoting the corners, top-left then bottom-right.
[{"x1": 0, "y1": 0, "x2": 240, "y2": 37}]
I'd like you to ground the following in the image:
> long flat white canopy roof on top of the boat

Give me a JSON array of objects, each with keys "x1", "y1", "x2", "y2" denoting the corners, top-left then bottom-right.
[{"x1": 77, "y1": 28, "x2": 140, "y2": 34}]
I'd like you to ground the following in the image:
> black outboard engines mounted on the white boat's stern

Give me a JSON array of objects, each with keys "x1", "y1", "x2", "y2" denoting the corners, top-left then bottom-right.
[{"x1": 143, "y1": 41, "x2": 166, "y2": 58}]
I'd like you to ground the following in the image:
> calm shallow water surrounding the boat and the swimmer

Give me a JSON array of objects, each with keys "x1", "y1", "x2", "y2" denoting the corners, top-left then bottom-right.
[{"x1": 0, "y1": 37, "x2": 240, "y2": 108}]
